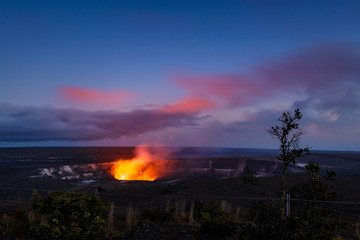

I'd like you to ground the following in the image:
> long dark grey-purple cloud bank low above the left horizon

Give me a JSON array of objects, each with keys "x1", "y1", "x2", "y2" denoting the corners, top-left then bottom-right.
[{"x1": 0, "y1": 104, "x2": 198, "y2": 142}]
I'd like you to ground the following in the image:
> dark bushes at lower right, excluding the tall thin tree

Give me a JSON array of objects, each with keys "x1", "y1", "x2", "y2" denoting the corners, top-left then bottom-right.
[{"x1": 240, "y1": 162, "x2": 349, "y2": 240}]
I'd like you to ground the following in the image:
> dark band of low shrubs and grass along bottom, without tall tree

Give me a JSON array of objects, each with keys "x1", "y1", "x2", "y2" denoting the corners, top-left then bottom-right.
[{"x1": 0, "y1": 164, "x2": 356, "y2": 239}]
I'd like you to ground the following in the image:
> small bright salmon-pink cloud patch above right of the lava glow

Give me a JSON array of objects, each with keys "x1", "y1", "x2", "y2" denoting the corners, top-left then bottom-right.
[{"x1": 160, "y1": 97, "x2": 216, "y2": 114}]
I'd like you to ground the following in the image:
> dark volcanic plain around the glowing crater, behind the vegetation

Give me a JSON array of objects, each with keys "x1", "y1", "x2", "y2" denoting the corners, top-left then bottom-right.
[{"x1": 0, "y1": 147, "x2": 360, "y2": 219}]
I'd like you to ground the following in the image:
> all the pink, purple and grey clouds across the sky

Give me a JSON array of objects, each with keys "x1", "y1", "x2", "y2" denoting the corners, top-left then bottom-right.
[{"x1": 0, "y1": 45, "x2": 360, "y2": 150}]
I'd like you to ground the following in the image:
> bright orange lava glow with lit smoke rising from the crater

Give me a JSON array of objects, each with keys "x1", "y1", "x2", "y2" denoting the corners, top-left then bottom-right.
[{"x1": 110, "y1": 147, "x2": 170, "y2": 181}]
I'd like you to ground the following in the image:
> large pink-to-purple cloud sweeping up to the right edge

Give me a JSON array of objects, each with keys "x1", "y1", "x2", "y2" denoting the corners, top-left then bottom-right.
[{"x1": 172, "y1": 45, "x2": 360, "y2": 107}]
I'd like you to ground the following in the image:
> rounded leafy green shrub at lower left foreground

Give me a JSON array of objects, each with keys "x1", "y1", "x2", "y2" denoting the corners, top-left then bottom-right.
[{"x1": 29, "y1": 192, "x2": 107, "y2": 240}]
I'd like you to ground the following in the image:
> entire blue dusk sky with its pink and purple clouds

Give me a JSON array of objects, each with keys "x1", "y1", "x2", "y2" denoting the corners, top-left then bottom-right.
[{"x1": 0, "y1": 0, "x2": 360, "y2": 151}]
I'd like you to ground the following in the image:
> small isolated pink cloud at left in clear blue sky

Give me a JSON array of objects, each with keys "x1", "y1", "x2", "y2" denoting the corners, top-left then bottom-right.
[{"x1": 59, "y1": 86, "x2": 133, "y2": 105}]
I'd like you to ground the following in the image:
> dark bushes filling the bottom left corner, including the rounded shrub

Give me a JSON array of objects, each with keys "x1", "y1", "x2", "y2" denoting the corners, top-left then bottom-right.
[{"x1": 0, "y1": 191, "x2": 108, "y2": 240}]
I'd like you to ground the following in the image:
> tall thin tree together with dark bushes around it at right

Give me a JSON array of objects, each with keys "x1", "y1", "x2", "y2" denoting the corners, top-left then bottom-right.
[{"x1": 240, "y1": 109, "x2": 348, "y2": 240}]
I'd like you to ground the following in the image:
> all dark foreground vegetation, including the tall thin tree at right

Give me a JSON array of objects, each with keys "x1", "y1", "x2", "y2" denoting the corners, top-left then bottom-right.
[{"x1": 0, "y1": 109, "x2": 360, "y2": 240}]
